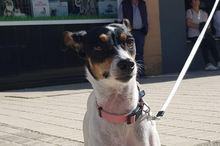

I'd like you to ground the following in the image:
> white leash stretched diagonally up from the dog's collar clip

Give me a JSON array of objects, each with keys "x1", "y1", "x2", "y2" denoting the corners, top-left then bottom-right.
[{"x1": 151, "y1": 0, "x2": 219, "y2": 120}]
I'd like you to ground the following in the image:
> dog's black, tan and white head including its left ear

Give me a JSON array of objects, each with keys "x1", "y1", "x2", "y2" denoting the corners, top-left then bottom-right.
[{"x1": 63, "y1": 20, "x2": 137, "y2": 83}]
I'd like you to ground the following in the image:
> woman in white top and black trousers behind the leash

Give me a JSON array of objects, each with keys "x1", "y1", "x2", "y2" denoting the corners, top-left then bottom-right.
[{"x1": 186, "y1": 0, "x2": 220, "y2": 71}]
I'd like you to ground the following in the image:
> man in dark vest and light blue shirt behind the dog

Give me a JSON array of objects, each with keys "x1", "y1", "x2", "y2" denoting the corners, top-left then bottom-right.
[{"x1": 118, "y1": 0, "x2": 149, "y2": 76}]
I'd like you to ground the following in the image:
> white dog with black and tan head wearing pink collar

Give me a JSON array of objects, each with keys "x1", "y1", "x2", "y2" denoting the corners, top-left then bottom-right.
[{"x1": 64, "y1": 20, "x2": 160, "y2": 146}]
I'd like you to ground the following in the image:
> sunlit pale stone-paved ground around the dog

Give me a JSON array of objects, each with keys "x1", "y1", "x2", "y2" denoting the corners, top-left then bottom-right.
[{"x1": 0, "y1": 71, "x2": 220, "y2": 146}]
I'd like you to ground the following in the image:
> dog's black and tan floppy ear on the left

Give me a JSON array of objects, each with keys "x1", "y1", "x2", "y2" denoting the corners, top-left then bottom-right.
[{"x1": 63, "y1": 31, "x2": 87, "y2": 58}]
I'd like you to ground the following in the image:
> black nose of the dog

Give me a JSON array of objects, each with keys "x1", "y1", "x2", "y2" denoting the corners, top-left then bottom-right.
[{"x1": 118, "y1": 59, "x2": 134, "y2": 73}]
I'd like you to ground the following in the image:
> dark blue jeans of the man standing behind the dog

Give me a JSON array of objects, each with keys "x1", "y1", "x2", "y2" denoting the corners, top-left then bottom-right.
[{"x1": 132, "y1": 29, "x2": 145, "y2": 76}]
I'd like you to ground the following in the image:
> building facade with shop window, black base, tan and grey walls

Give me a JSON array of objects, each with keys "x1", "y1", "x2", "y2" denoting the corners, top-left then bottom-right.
[{"x1": 0, "y1": 0, "x2": 218, "y2": 90}]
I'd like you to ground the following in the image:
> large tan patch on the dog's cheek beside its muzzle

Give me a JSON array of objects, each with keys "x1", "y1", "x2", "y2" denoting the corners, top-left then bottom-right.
[{"x1": 88, "y1": 58, "x2": 113, "y2": 80}]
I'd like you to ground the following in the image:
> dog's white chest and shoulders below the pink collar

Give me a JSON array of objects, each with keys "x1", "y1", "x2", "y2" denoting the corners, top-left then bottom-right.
[{"x1": 83, "y1": 93, "x2": 159, "y2": 146}]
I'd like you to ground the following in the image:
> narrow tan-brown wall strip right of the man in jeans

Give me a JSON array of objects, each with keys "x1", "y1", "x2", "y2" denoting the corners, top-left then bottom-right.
[{"x1": 144, "y1": 0, "x2": 162, "y2": 75}]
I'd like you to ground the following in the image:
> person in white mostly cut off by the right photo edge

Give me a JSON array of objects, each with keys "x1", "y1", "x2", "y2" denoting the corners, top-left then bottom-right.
[{"x1": 214, "y1": 3, "x2": 220, "y2": 38}]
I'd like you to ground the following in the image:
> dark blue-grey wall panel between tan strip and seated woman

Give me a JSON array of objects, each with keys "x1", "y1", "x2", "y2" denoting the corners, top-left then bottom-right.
[{"x1": 159, "y1": 0, "x2": 187, "y2": 74}]
